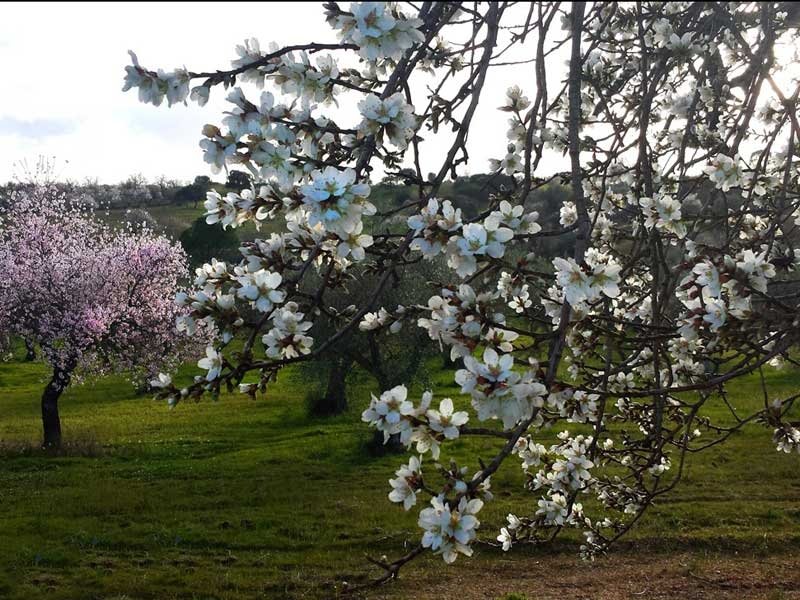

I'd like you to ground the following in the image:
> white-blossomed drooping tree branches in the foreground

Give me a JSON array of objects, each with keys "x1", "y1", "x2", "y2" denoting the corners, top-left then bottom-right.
[{"x1": 120, "y1": 2, "x2": 800, "y2": 580}]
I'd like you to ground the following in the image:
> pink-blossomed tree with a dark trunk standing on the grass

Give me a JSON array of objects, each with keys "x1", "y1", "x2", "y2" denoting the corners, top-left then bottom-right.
[{"x1": 0, "y1": 185, "x2": 186, "y2": 447}]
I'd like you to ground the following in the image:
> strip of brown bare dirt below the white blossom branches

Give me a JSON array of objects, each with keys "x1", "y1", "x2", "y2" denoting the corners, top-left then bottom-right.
[{"x1": 382, "y1": 552, "x2": 800, "y2": 600}]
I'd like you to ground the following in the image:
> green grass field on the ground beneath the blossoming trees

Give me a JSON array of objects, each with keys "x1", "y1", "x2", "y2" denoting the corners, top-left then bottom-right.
[{"x1": 0, "y1": 342, "x2": 800, "y2": 600}]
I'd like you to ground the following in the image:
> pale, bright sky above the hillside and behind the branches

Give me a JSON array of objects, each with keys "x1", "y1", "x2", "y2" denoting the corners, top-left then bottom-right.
[{"x1": 0, "y1": 2, "x2": 556, "y2": 183}]
